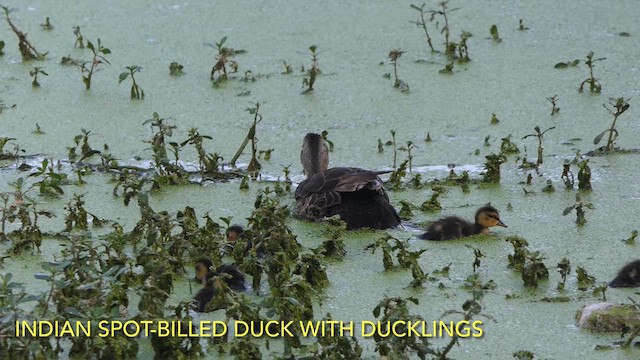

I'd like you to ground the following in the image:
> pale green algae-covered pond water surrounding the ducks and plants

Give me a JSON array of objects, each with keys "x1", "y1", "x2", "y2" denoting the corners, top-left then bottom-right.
[{"x1": 0, "y1": 0, "x2": 640, "y2": 359}]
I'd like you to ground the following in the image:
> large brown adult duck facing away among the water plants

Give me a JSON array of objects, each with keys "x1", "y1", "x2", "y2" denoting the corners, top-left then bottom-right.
[{"x1": 294, "y1": 133, "x2": 400, "y2": 229}]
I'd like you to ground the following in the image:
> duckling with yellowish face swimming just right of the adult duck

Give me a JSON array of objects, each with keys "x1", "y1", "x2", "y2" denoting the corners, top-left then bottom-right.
[{"x1": 420, "y1": 206, "x2": 507, "y2": 240}]
